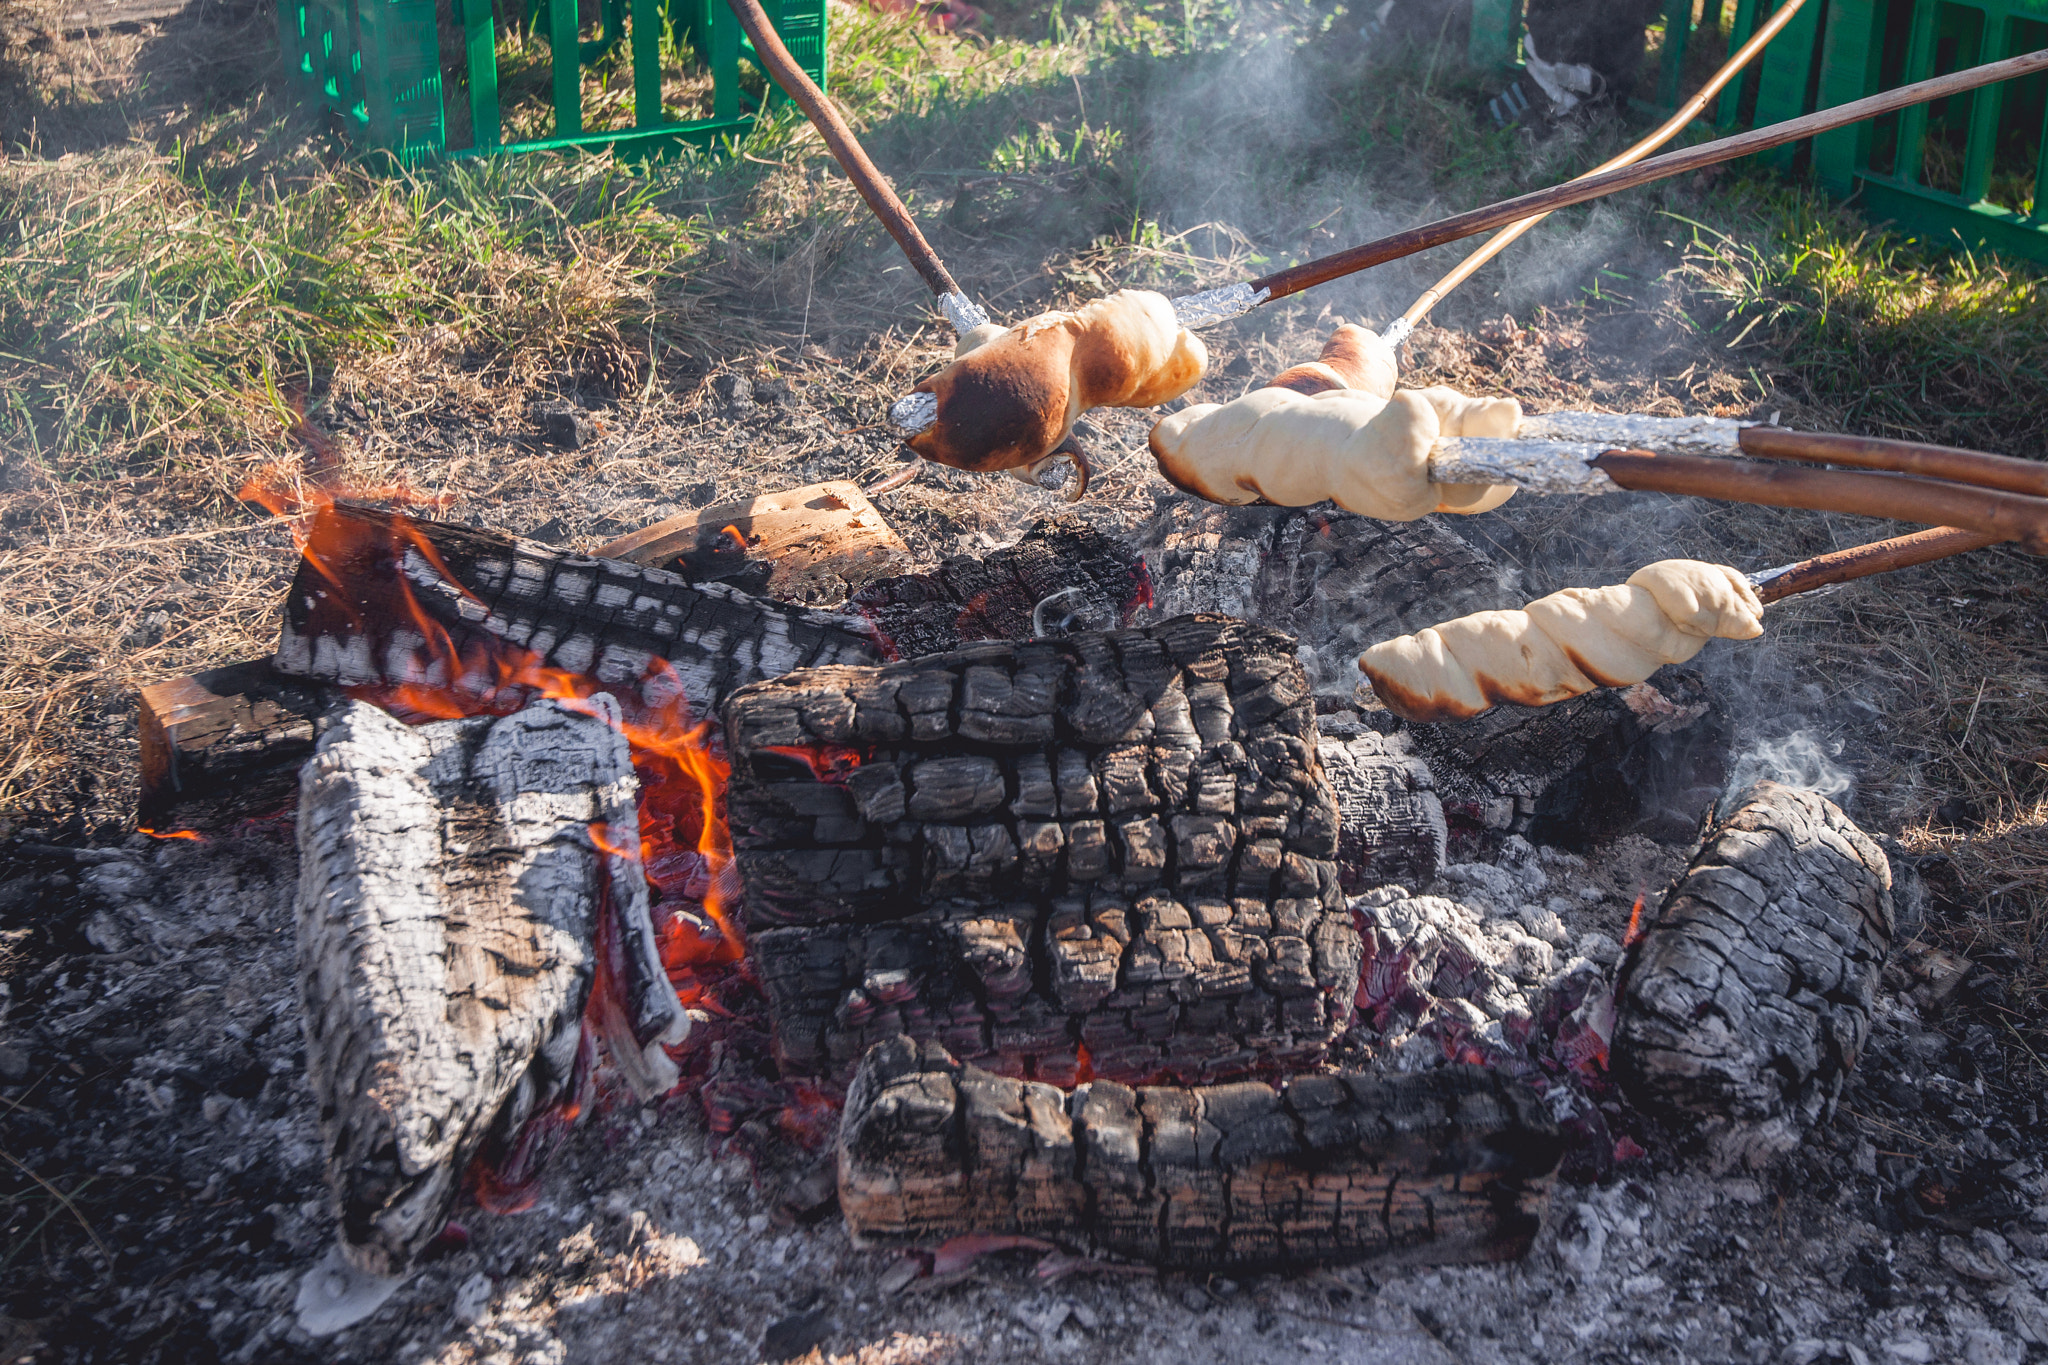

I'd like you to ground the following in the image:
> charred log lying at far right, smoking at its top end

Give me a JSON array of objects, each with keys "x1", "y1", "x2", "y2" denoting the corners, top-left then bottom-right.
[{"x1": 1612, "y1": 782, "x2": 1892, "y2": 1166}]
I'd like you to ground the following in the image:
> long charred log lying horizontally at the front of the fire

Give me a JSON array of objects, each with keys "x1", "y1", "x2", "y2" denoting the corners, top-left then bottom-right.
[{"x1": 840, "y1": 1038, "x2": 1561, "y2": 1271}]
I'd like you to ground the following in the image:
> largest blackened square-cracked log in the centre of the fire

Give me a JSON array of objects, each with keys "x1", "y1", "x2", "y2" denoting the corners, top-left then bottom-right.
[{"x1": 727, "y1": 616, "x2": 1360, "y2": 1085}]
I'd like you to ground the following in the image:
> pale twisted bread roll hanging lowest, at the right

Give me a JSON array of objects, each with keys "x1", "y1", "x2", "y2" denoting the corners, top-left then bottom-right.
[{"x1": 1358, "y1": 559, "x2": 1763, "y2": 720}]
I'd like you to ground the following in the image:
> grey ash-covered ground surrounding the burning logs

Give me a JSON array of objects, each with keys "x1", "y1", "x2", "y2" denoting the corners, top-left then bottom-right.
[{"x1": 0, "y1": 378, "x2": 2048, "y2": 1365}]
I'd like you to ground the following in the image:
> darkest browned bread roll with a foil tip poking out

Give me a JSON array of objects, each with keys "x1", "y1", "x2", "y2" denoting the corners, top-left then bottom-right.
[{"x1": 907, "y1": 289, "x2": 1208, "y2": 471}]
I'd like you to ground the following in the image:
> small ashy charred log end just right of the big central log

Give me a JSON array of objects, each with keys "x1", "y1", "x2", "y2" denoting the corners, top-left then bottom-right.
[{"x1": 1317, "y1": 731, "x2": 1450, "y2": 894}]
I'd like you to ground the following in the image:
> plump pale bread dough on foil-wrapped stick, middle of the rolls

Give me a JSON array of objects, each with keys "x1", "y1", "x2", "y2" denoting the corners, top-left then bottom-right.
[{"x1": 1151, "y1": 382, "x2": 1522, "y2": 522}]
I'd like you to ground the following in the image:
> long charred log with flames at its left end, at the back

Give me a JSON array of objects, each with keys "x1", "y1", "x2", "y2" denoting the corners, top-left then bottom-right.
[{"x1": 272, "y1": 503, "x2": 881, "y2": 714}]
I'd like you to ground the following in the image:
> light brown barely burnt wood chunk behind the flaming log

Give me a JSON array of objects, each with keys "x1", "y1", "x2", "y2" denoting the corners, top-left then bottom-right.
[{"x1": 594, "y1": 479, "x2": 911, "y2": 606}]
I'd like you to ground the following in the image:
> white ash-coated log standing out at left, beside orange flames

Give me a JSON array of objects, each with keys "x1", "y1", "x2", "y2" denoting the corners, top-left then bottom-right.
[{"x1": 297, "y1": 694, "x2": 688, "y2": 1275}]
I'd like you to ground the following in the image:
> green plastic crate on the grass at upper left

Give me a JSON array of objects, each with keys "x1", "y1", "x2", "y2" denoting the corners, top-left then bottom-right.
[{"x1": 279, "y1": 0, "x2": 825, "y2": 166}]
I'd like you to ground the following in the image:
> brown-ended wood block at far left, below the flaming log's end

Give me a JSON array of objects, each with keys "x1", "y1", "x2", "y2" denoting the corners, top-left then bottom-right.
[{"x1": 135, "y1": 659, "x2": 340, "y2": 831}]
